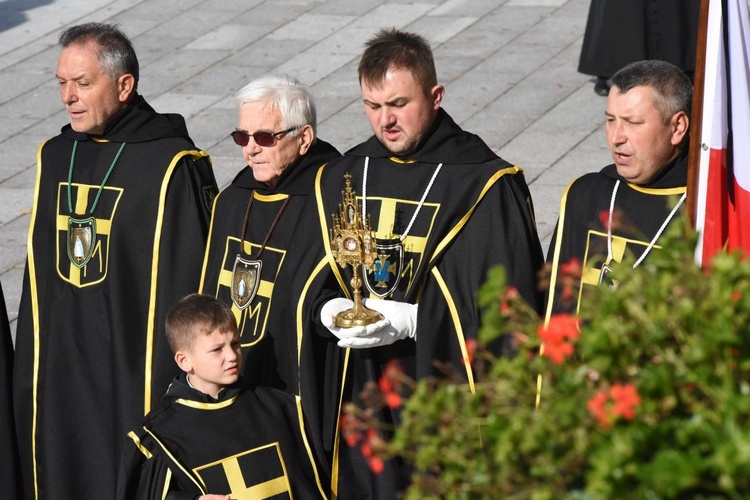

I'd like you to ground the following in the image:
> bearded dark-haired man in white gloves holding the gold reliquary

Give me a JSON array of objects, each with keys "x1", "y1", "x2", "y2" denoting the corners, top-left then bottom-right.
[{"x1": 309, "y1": 29, "x2": 543, "y2": 498}]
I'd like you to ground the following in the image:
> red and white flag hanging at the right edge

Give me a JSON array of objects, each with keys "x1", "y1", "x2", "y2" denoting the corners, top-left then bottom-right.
[{"x1": 695, "y1": 0, "x2": 750, "y2": 265}]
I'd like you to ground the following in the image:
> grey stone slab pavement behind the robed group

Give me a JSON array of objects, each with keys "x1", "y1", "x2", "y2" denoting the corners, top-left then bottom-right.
[{"x1": 0, "y1": 0, "x2": 610, "y2": 331}]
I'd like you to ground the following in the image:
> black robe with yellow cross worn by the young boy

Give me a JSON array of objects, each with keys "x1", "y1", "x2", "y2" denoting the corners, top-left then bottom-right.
[{"x1": 116, "y1": 373, "x2": 327, "y2": 500}]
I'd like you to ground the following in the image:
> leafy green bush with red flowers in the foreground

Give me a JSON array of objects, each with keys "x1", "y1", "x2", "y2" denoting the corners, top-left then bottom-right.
[{"x1": 356, "y1": 223, "x2": 750, "y2": 499}]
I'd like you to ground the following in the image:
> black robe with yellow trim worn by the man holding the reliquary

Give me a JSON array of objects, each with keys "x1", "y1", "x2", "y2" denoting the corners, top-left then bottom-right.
[{"x1": 307, "y1": 110, "x2": 543, "y2": 498}]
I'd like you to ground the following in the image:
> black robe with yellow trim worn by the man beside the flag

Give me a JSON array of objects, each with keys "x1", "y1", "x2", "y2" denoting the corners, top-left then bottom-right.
[{"x1": 545, "y1": 151, "x2": 687, "y2": 319}]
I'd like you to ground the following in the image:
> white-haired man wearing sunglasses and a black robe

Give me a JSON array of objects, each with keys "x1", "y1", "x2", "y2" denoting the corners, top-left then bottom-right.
[{"x1": 200, "y1": 75, "x2": 340, "y2": 486}]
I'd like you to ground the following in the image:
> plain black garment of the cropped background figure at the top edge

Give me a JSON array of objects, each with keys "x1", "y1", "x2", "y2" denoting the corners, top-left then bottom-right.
[{"x1": 578, "y1": 0, "x2": 700, "y2": 78}]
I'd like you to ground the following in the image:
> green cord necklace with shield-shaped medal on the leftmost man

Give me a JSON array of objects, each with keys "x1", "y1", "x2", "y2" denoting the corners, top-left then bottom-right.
[{"x1": 68, "y1": 141, "x2": 127, "y2": 268}]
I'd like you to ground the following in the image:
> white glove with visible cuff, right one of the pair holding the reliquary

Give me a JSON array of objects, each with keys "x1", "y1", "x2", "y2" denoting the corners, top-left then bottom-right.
[{"x1": 338, "y1": 299, "x2": 417, "y2": 349}]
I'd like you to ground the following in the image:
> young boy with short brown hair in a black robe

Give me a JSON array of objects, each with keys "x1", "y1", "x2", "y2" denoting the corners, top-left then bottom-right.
[{"x1": 117, "y1": 294, "x2": 327, "y2": 500}]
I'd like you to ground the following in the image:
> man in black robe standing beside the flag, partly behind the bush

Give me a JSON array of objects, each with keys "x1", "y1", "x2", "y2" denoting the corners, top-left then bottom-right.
[{"x1": 546, "y1": 60, "x2": 692, "y2": 319}]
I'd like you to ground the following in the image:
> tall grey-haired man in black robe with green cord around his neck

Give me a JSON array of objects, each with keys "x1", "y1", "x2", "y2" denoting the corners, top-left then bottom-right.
[{"x1": 13, "y1": 23, "x2": 216, "y2": 498}]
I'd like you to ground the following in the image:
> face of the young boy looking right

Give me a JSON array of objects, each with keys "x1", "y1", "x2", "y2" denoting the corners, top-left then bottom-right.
[{"x1": 175, "y1": 329, "x2": 242, "y2": 398}]
